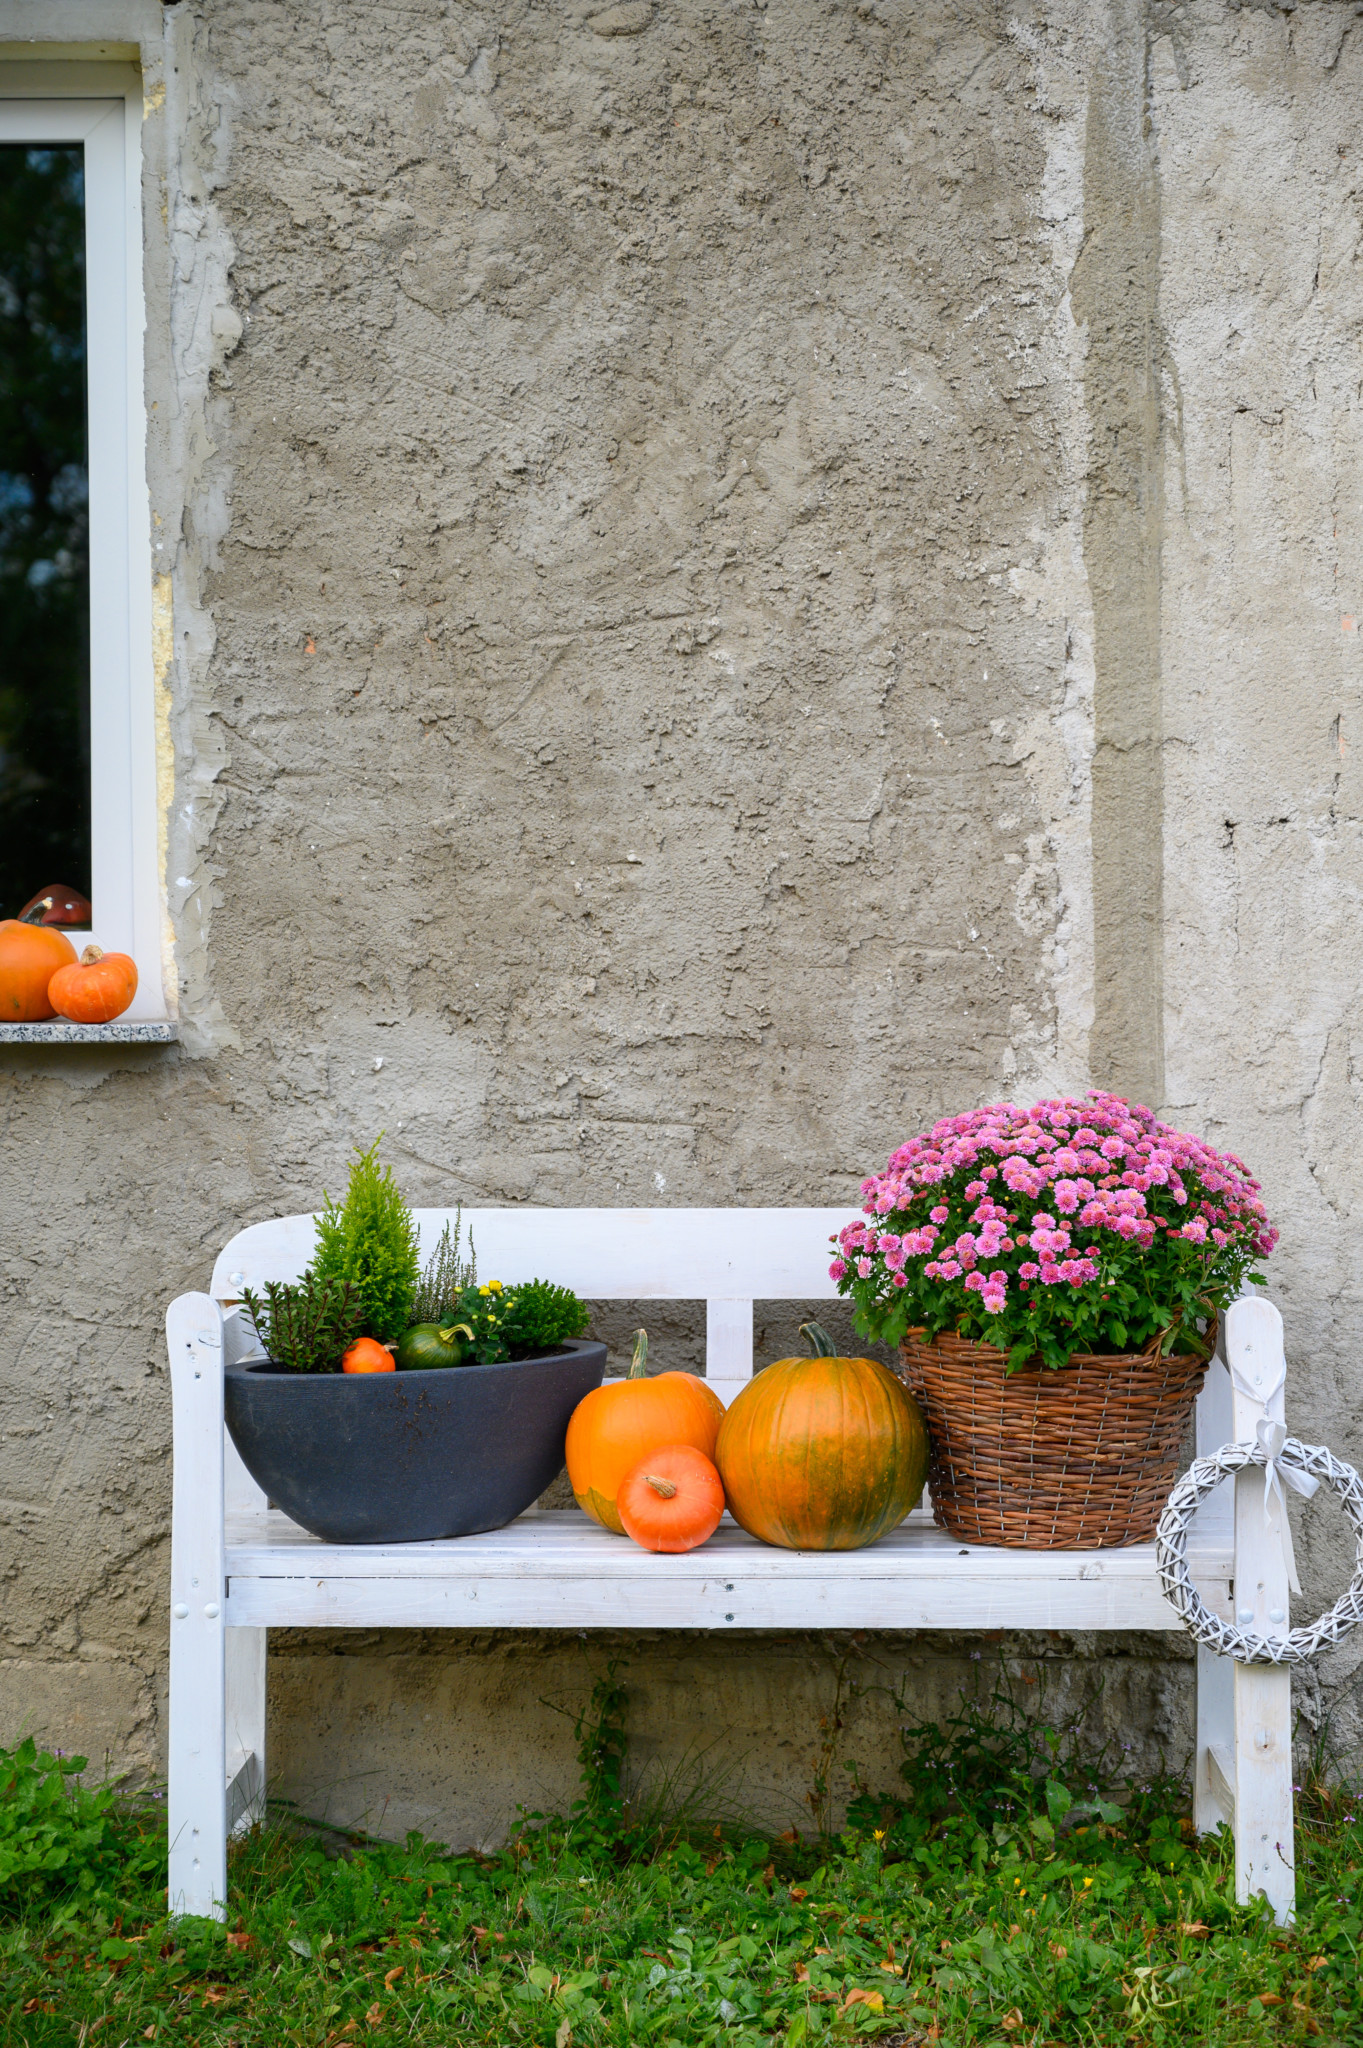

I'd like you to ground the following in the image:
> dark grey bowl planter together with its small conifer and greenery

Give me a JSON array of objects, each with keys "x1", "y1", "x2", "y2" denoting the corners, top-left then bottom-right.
[{"x1": 225, "y1": 1143, "x2": 606, "y2": 1542}]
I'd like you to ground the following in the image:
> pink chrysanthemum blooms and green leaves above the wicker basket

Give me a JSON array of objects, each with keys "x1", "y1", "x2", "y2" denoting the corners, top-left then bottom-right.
[{"x1": 831, "y1": 1092, "x2": 1277, "y2": 1372}]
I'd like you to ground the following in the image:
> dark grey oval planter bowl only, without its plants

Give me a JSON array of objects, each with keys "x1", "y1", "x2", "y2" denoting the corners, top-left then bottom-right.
[{"x1": 225, "y1": 1341, "x2": 606, "y2": 1542}]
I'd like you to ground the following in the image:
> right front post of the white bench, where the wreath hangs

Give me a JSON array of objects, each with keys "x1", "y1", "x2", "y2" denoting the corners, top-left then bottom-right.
[{"x1": 1226, "y1": 1296, "x2": 1295, "y2": 1925}]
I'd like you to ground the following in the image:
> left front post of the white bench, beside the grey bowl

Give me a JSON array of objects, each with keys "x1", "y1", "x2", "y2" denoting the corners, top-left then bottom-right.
[{"x1": 166, "y1": 1294, "x2": 227, "y2": 1919}]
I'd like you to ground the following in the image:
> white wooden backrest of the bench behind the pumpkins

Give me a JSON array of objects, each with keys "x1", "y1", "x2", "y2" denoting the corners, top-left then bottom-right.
[{"x1": 211, "y1": 1208, "x2": 855, "y2": 1399}]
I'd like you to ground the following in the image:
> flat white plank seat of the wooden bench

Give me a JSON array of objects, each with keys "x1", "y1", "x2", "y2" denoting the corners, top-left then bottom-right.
[{"x1": 227, "y1": 1511, "x2": 1230, "y2": 1628}]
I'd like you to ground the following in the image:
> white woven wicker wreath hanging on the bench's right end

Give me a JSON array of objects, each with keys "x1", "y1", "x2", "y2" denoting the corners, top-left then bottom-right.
[{"x1": 1156, "y1": 1436, "x2": 1363, "y2": 1663}]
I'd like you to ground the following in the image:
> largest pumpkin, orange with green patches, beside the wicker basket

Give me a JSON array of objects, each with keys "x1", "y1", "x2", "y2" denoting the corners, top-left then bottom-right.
[{"x1": 714, "y1": 1323, "x2": 927, "y2": 1550}]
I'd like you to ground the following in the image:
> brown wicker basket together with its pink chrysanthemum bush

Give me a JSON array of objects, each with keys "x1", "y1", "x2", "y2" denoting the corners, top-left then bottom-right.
[{"x1": 831, "y1": 1094, "x2": 1277, "y2": 1548}]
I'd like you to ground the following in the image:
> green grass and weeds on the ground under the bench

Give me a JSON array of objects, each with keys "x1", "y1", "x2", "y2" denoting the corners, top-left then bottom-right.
[{"x1": 0, "y1": 1679, "x2": 1363, "y2": 2048}]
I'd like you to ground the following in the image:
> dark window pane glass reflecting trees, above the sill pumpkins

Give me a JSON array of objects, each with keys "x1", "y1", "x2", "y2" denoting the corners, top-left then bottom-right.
[{"x1": 0, "y1": 155, "x2": 90, "y2": 918}]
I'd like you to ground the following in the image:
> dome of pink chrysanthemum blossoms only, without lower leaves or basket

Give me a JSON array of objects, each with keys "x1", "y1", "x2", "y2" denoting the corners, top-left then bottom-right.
[{"x1": 829, "y1": 1094, "x2": 1277, "y2": 1315}]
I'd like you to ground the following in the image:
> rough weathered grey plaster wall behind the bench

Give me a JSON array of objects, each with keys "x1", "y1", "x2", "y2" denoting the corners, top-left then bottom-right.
[{"x1": 0, "y1": 0, "x2": 1363, "y2": 1839}]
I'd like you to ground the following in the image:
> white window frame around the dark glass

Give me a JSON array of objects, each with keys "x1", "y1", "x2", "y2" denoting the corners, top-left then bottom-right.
[{"x1": 0, "y1": 86, "x2": 168, "y2": 1022}]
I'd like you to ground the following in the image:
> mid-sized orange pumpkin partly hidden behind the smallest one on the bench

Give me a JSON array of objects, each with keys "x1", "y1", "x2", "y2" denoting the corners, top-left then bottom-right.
[{"x1": 567, "y1": 1329, "x2": 724, "y2": 1536}]
